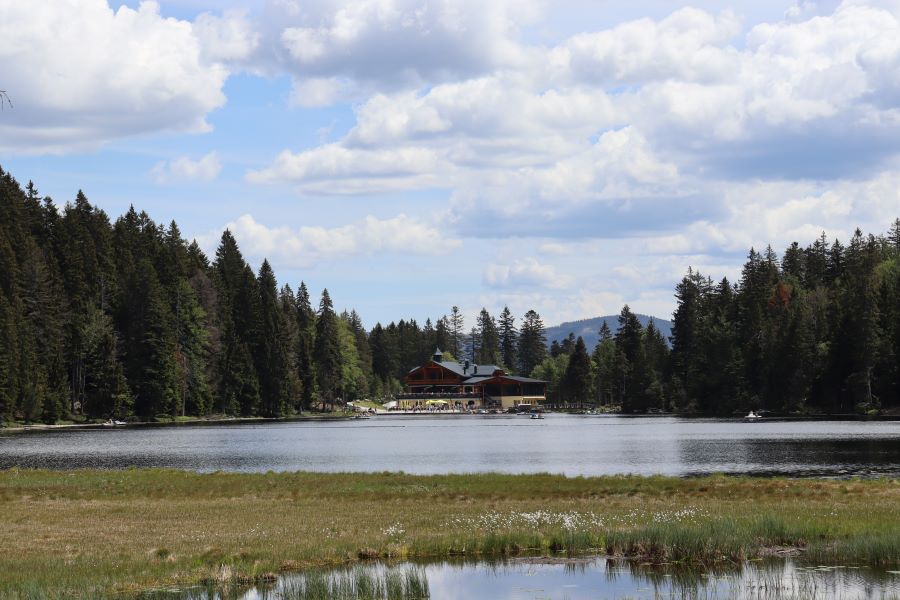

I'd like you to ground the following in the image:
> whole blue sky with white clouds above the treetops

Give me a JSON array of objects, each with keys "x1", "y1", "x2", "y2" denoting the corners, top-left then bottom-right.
[{"x1": 0, "y1": 0, "x2": 900, "y2": 326}]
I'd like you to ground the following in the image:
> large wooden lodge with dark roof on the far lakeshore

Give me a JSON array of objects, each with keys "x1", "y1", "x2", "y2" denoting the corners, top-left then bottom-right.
[{"x1": 396, "y1": 349, "x2": 547, "y2": 410}]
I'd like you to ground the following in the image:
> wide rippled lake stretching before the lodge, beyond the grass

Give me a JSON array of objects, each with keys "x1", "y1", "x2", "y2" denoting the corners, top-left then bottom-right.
[{"x1": 0, "y1": 414, "x2": 900, "y2": 476}]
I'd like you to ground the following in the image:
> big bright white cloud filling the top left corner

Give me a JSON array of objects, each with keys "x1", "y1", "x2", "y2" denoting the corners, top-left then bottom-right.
[{"x1": 0, "y1": 0, "x2": 228, "y2": 154}]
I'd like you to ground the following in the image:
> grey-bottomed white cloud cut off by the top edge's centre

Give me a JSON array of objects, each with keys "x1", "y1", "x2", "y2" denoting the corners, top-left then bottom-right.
[{"x1": 265, "y1": 0, "x2": 538, "y2": 88}]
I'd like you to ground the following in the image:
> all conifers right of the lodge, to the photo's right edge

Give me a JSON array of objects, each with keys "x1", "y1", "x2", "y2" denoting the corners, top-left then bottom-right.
[{"x1": 534, "y1": 219, "x2": 900, "y2": 415}]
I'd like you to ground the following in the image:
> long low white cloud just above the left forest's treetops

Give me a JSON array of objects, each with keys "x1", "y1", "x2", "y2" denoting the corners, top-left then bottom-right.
[{"x1": 198, "y1": 214, "x2": 460, "y2": 267}]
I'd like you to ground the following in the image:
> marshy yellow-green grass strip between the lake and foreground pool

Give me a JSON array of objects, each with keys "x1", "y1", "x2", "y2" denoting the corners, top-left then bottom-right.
[{"x1": 0, "y1": 469, "x2": 900, "y2": 598}]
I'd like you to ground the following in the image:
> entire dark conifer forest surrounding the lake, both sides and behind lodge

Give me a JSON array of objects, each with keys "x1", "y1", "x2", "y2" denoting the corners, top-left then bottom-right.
[{"x1": 0, "y1": 165, "x2": 900, "y2": 423}]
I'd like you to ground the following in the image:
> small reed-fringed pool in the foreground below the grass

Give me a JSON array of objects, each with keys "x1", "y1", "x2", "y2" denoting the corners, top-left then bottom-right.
[{"x1": 144, "y1": 558, "x2": 900, "y2": 600}]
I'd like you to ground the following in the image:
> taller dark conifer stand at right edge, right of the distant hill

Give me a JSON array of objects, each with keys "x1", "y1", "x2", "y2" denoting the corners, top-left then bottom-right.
[{"x1": 669, "y1": 227, "x2": 900, "y2": 414}]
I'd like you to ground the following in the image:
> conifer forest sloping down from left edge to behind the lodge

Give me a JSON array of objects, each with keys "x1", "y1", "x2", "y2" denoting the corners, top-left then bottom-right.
[{"x1": 0, "y1": 170, "x2": 546, "y2": 423}]
